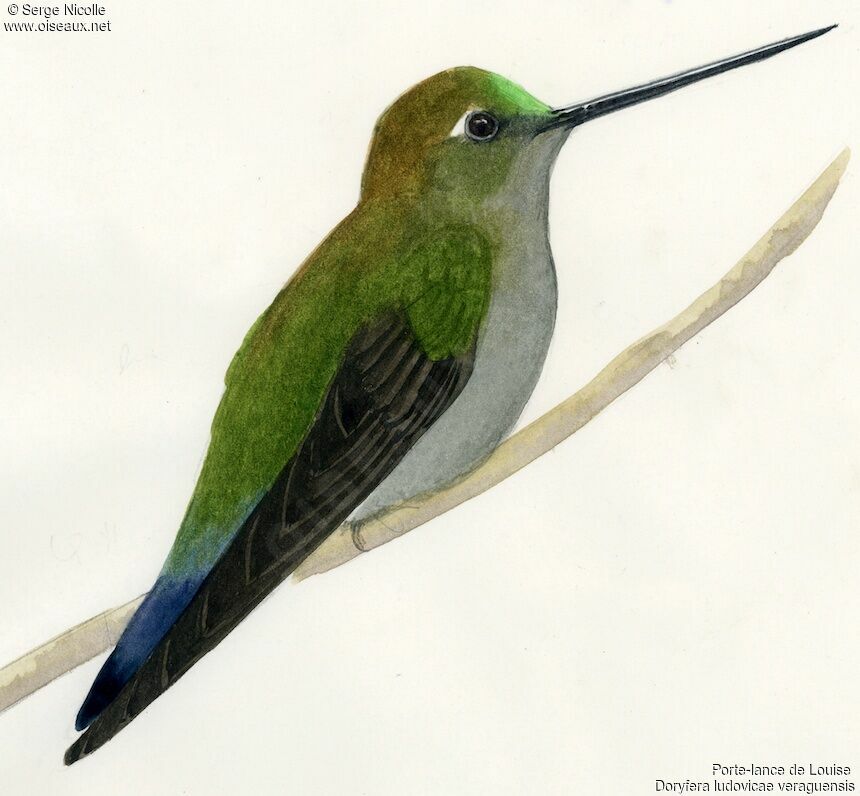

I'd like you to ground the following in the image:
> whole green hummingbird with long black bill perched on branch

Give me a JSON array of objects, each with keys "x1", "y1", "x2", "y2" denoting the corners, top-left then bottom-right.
[{"x1": 65, "y1": 25, "x2": 836, "y2": 765}]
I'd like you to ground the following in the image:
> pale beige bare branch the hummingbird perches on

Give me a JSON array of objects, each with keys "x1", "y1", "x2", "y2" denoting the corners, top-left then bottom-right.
[{"x1": 0, "y1": 149, "x2": 850, "y2": 711}]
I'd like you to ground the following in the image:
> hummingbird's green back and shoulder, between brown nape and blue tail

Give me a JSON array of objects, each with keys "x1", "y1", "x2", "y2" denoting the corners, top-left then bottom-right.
[{"x1": 165, "y1": 221, "x2": 492, "y2": 576}]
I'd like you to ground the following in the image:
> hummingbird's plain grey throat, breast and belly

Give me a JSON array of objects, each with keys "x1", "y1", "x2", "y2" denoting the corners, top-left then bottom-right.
[{"x1": 350, "y1": 127, "x2": 565, "y2": 521}]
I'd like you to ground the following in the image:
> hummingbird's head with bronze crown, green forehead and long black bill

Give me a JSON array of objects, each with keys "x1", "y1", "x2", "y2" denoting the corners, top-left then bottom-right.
[{"x1": 362, "y1": 25, "x2": 835, "y2": 210}]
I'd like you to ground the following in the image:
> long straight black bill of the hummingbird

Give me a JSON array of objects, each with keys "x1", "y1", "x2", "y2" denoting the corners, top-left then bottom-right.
[{"x1": 547, "y1": 25, "x2": 836, "y2": 129}]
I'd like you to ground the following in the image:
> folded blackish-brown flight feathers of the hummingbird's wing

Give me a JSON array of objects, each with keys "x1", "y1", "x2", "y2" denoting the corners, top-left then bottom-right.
[{"x1": 65, "y1": 314, "x2": 474, "y2": 765}]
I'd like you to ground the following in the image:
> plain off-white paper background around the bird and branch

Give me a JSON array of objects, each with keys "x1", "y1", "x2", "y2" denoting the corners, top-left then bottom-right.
[{"x1": 0, "y1": 0, "x2": 860, "y2": 796}]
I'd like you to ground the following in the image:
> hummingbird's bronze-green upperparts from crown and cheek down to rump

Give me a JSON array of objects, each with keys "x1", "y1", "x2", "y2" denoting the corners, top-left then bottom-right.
[{"x1": 164, "y1": 67, "x2": 549, "y2": 576}]
